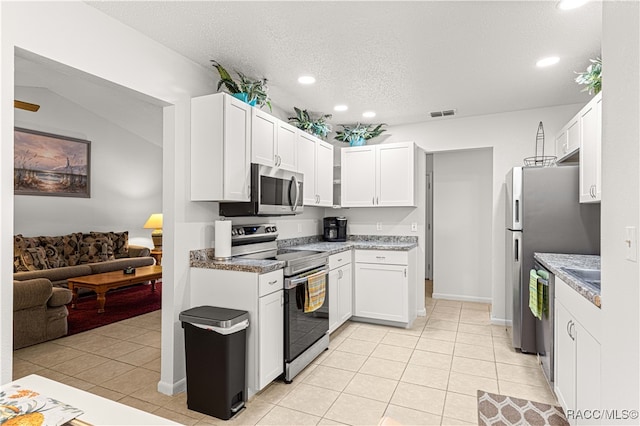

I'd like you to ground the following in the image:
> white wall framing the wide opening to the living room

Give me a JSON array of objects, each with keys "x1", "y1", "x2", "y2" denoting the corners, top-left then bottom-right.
[{"x1": 0, "y1": 2, "x2": 216, "y2": 393}]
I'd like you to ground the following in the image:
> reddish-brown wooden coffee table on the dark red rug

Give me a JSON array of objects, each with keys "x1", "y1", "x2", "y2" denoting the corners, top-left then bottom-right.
[{"x1": 67, "y1": 265, "x2": 162, "y2": 314}]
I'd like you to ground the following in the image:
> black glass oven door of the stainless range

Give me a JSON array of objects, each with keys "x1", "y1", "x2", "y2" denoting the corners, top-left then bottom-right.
[{"x1": 284, "y1": 267, "x2": 329, "y2": 363}]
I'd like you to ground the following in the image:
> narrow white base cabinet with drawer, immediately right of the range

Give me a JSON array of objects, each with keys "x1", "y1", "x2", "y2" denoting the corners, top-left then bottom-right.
[{"x1": 329, "y1": 250, "x2": 353, "y2": 333}]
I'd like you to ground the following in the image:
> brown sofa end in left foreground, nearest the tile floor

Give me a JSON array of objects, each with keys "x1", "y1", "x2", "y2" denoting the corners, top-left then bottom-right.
[{"x1": 13, "y1": 278, "x2": 72, "y2": 350}]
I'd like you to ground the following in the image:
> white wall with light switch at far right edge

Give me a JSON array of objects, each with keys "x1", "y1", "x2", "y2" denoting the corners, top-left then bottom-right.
[{"x1": 600, "y1": 2, "x2": 640, "y2": 416}]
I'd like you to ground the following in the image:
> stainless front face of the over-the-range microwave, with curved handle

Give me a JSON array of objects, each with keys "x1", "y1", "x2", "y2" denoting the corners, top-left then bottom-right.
[{"x1": 251, "y1": 164, "x2": 304, "y2": 215}]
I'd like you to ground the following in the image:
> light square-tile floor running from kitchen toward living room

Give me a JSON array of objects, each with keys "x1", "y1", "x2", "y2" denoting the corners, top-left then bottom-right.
[{"x1": 13, "y1": 290, "x2": 557, "y2": 425}]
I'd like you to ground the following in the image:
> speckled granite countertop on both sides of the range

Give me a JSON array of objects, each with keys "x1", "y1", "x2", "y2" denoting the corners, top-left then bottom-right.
[{"x1": 189, "y1": 235, "x2": 418, "y2": 274}]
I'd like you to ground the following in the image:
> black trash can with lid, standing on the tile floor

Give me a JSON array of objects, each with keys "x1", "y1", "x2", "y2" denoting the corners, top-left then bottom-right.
[{"x1": 179, "y1": 306, "x2": 249, "y2": 420}]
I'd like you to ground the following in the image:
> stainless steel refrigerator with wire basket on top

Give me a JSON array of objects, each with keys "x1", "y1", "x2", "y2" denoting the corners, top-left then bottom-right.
[{"x1": 505, "y1": 165, "x2": 600, "y2": 353}]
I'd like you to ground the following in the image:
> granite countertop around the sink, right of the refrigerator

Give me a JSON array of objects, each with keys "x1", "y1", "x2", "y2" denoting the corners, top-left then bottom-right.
[{"x1": 534, "y1": 253, "x2": 602, "y2": 308}]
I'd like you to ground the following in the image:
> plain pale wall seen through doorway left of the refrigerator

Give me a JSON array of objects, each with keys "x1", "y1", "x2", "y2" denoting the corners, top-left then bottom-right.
[{"x1": 433, "y1": 148, "x2": 493, "y2": 303}]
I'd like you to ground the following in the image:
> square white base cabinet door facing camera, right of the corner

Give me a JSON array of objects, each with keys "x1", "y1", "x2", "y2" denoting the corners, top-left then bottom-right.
[{"x1": 355, "y1": 263, "x2": 409, "y2": 322}]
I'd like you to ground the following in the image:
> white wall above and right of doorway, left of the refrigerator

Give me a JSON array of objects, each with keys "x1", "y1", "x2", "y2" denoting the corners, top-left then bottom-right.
[{"x1": 380, "y1": 104, "x2": 582, "y2": 323}]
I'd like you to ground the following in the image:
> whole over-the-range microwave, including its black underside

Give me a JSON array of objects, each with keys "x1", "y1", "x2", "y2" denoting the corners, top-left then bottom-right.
[{"x1": 220, "y1": 163, "x2": 304, "y2": 217}]
